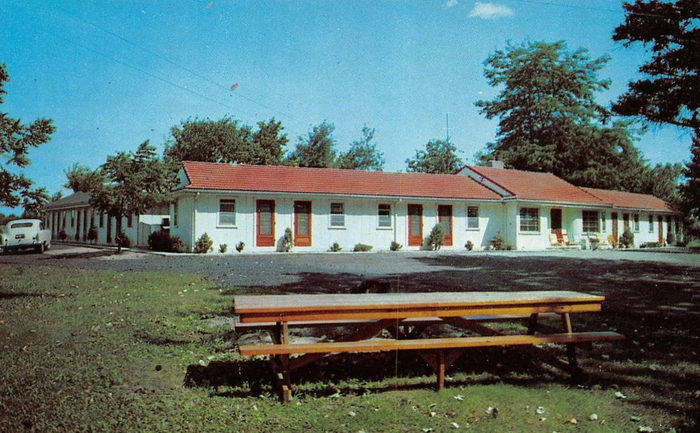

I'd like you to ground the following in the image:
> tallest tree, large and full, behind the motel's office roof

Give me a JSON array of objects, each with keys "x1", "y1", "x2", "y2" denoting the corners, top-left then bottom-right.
[{"x1": 476, "y1": 41, "x2": 645, "y2": 190}]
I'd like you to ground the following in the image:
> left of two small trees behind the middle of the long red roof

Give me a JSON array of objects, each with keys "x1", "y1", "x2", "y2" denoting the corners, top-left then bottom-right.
[{"x1": 288, "y1": 120, "x2": 335, "y2": 167}]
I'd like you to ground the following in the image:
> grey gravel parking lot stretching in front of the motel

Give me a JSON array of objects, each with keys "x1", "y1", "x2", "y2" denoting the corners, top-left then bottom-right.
[{"x1": 0, "y1": 245, "x2": 700, "y2": 293}]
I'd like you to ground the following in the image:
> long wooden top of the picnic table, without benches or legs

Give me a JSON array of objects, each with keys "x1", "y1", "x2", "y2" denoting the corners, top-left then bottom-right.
[{"x1": 234, "y1": 291, "x2": 605, "y2": 322}]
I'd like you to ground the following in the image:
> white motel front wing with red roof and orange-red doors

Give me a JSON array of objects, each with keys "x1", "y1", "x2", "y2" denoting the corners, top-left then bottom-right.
[{"x1": 161, "y1": 162, "x2": 681, "y2": 254}]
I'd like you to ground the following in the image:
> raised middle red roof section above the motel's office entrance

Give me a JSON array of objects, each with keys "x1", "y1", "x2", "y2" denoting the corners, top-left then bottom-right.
[{"x1": 467, "y1": 166, "x2": 609, "y2": 205}]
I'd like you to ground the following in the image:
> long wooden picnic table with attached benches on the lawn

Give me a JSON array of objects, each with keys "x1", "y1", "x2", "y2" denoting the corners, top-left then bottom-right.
[{"x1": 234, "y1": 291, "x2": 624, "y2": 402}]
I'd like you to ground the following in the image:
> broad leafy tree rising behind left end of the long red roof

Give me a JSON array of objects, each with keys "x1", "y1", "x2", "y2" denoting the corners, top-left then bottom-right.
[{"x1": 165, "y1": 117, "x2": 255, "y2": 164}]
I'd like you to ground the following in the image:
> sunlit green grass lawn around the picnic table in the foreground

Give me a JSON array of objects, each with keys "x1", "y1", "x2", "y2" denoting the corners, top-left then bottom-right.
[{"x1": 0, "y1": 265, "x2": 700, "y2": 433}]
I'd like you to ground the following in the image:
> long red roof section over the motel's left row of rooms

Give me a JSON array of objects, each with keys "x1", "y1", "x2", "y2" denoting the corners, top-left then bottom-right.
[{"x1": 182, "y1": 161, "x2": 501, "y2": 200}]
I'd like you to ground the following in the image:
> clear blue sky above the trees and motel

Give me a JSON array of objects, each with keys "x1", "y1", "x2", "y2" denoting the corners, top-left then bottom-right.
[{"x1": 0, "y1": 0, "x2": 691, "y2": 213}]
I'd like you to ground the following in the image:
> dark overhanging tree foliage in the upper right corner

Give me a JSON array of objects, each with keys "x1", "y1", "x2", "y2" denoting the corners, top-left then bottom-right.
[{"x1": 613, "y1": 0, "x2": 700, "y2": 129}]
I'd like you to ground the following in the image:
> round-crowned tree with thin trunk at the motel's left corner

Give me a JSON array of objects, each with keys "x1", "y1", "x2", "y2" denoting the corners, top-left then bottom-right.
[{"x1": 90, "y1": 140, "x2": 176, "y2": 252}]
